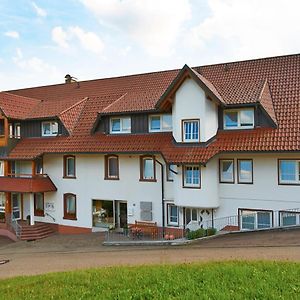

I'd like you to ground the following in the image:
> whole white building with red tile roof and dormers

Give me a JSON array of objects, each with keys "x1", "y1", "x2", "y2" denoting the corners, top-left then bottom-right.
[{"x1": 0, "y1": 55, "x2": 300, "y2": 239}]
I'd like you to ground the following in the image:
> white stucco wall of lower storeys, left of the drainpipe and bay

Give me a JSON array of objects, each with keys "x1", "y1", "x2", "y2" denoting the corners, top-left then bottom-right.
[{"x1": 39, "y1": 154, "x2": 173, "y2": 228}]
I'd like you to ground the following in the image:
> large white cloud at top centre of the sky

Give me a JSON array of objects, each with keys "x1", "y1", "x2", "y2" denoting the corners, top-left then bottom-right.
[{"x1": 81, "y1": 0, "x2": 191, "y2": 56}]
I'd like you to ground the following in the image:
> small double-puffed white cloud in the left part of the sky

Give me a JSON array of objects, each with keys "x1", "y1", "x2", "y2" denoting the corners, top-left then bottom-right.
[{"x1": 52, "y1": 26, "x2": 104, "y2": 54}]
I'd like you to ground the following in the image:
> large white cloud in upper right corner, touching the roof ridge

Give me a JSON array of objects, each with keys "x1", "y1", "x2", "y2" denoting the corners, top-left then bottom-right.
[{"x1": 188, "y1": 0, "x2": 300, "y2": 58}]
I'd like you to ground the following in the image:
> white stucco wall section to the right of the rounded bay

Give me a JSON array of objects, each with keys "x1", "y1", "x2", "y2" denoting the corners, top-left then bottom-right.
[{"x1": 215, "y1": 154, "x2": 300, "y2": 217}]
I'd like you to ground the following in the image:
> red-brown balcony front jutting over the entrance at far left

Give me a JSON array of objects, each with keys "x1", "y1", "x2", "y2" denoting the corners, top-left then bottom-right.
[{"x1": 0, "y1": 174, "x2": 57, "y2": 193}]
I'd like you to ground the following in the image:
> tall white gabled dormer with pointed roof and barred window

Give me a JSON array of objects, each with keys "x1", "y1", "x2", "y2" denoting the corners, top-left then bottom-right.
[{"x1": 156, "y1": 65, "x2": 223, "y2": 143}]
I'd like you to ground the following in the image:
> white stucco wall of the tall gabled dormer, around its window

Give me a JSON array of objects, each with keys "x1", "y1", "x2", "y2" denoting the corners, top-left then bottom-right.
[{"x1": 172, "y1": 79, "x2": 218, "y2": 142}]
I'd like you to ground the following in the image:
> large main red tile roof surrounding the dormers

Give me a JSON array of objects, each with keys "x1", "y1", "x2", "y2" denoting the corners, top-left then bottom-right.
[{"x1": 2, "y1": 55, "x2": 300, "y2": 163}]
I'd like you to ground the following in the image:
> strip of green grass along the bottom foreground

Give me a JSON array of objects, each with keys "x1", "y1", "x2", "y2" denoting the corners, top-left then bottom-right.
[{"x1": 0, "y1": 261, "x2": 300, "y2": 299}]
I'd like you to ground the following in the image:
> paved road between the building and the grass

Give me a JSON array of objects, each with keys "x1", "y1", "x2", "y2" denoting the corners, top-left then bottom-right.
[{"x1": 0, "y1": 230, "x2": 300, "y2": 278}]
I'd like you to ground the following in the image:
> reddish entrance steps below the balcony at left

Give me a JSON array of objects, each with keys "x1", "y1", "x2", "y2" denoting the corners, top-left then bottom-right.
[{"x1": 20, "y1": 223, "x2": 54, "y2": 241}]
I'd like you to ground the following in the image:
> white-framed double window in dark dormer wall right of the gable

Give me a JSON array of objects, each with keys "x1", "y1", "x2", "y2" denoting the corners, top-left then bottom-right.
[{"x1": 224, "y1": 108, "x2": 254, "y2": 129}]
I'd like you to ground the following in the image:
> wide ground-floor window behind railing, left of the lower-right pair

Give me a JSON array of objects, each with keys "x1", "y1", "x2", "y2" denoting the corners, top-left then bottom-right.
[{"x1": 239, "y1": 209, "x2": 273, "y2": 230}]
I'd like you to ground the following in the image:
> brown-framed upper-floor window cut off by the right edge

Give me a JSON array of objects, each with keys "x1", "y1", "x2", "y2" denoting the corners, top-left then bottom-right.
[{"x1": 278, "y1": 160, "x2": 300, "y2": 184}]
